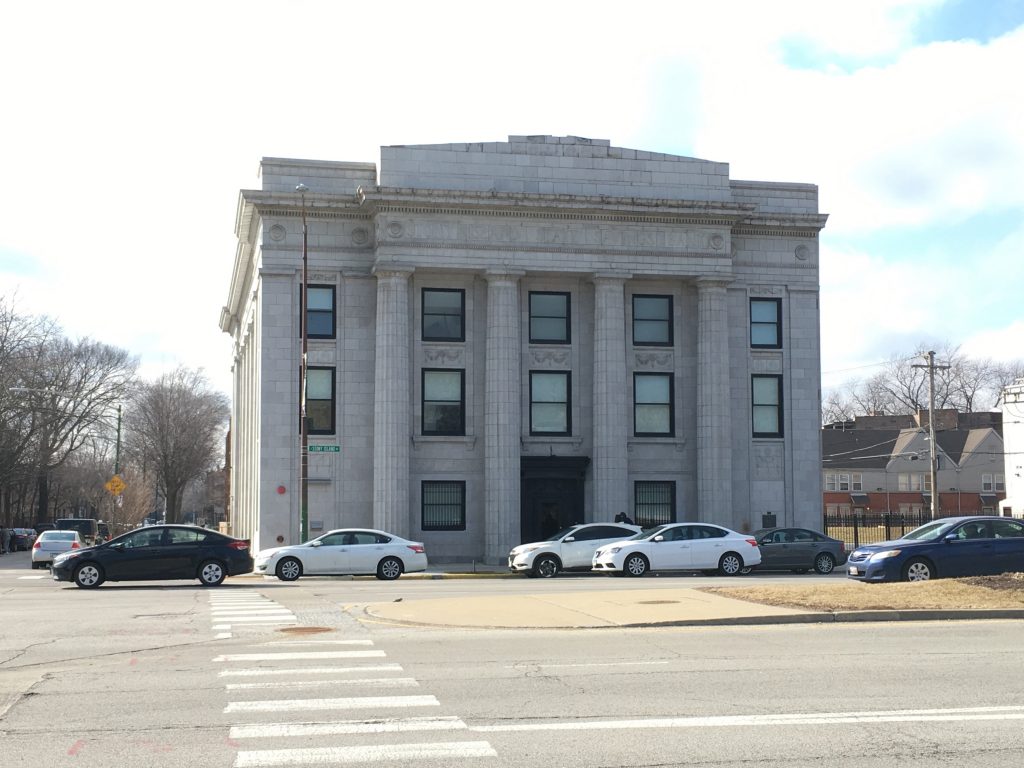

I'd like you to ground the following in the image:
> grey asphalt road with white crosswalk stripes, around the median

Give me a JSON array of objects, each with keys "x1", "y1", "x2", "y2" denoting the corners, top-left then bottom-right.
[{"x1": 6, "y1": 558, "x2": 1024, "y2": 768}]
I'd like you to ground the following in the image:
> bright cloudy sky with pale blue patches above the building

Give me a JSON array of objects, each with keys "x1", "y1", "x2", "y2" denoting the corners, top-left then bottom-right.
[{"x1": 0, "y1": 0, "x2": 1024, "y2": 391}]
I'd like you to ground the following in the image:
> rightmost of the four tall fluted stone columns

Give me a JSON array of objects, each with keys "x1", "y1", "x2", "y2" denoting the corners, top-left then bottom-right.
[{"x1": 697, "y1": 279, "x2": 733, "y2": 525}]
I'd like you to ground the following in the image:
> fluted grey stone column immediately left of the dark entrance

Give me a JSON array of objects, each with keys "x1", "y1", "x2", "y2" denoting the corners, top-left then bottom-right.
[{"x1": 483, "y1": 270, "x2": 523, "y2": 562}]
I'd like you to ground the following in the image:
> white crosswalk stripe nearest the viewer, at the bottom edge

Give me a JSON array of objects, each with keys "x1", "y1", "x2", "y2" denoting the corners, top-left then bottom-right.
[{"x1": 234, "y1": 741, "x2": 498, "y2": 768}]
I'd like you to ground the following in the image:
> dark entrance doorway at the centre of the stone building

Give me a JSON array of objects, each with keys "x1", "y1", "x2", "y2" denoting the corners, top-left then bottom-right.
[{"x1": 519, "y1": 456, "x2": 590, "y2": 543}]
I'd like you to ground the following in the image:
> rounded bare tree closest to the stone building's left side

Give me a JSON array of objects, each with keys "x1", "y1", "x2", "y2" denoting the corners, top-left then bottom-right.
[{"x1": 125, "y1": 368, "x2": 228, "y2": 522}]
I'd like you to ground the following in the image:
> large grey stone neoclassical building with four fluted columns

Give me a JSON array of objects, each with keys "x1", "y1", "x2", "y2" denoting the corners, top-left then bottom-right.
[{"x1": 220, "y1": 136, "x2": 826, "y2": 561}]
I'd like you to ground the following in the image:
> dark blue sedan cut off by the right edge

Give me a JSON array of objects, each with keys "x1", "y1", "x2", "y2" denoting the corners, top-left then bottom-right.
[{"x1": 847, "y1": 516, "x2": 1024, "y2": 582}]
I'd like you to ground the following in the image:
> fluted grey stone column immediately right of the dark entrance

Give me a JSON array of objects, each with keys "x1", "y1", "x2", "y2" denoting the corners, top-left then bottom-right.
[{"x1": 593, "y1": 273, "x2": 633, "y2": 522}]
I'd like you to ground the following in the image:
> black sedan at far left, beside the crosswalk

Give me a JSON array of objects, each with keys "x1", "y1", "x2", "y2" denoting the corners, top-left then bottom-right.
[{"x1": 52, "y1": 525, "x2": 253, "y2": 589}]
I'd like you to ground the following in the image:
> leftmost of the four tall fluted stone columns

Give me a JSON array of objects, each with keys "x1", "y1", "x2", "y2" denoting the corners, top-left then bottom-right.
[{"x1": 374, "y1": 267, "x2": 413, "y2": 537}]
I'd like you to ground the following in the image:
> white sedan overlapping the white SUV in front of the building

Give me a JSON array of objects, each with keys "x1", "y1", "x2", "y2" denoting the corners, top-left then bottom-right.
[{"x1": 592, "y1": 522, "x2": 761, "y2": 577}]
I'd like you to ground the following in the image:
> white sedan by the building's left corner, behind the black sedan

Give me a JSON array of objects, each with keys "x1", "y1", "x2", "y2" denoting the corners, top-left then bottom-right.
[{"x1": 255, "y1": 528, "x2": 427, "y2": 582}]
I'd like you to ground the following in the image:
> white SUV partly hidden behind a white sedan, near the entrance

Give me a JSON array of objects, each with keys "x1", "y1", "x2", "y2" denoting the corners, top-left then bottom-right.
[{"x1": 509, "y1": 522, "x2": 640, "y2": 579}]
